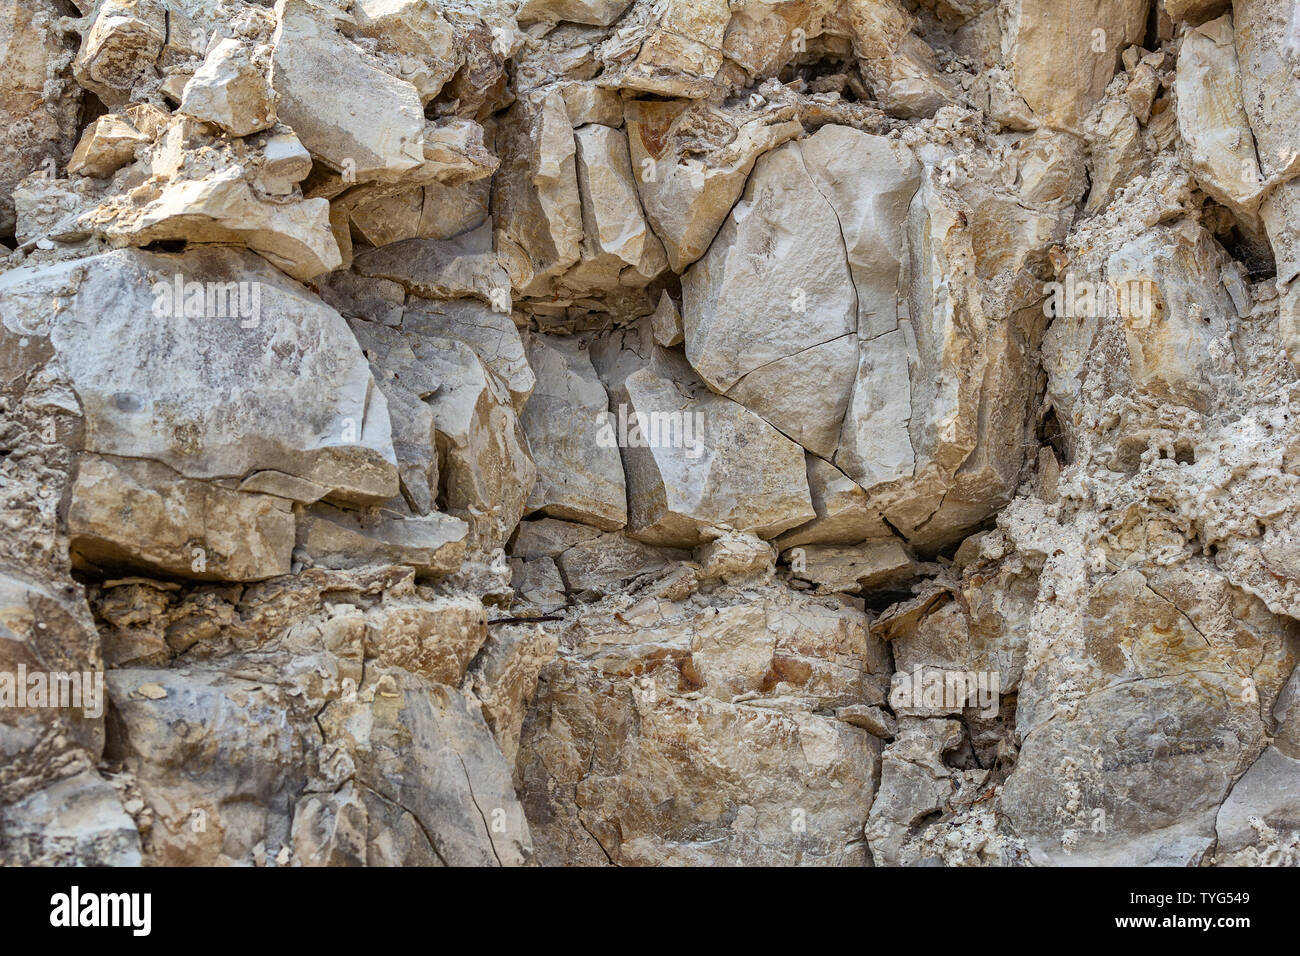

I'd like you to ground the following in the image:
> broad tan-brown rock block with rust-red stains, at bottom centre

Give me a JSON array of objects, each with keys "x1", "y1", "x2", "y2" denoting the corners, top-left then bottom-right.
[{"x1": 519, "y1": 589, "x2": 883, "y2": 865}]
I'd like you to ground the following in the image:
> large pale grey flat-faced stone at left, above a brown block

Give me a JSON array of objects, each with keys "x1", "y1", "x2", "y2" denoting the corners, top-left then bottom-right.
[{"x1": 0, "y1": 250, "x2": 397, "y2": 501}]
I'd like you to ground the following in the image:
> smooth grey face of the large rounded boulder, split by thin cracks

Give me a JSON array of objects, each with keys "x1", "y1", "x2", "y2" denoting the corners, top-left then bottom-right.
[{"x1": 683, "y1": 126, "x2": 919, "y2": 463}]
